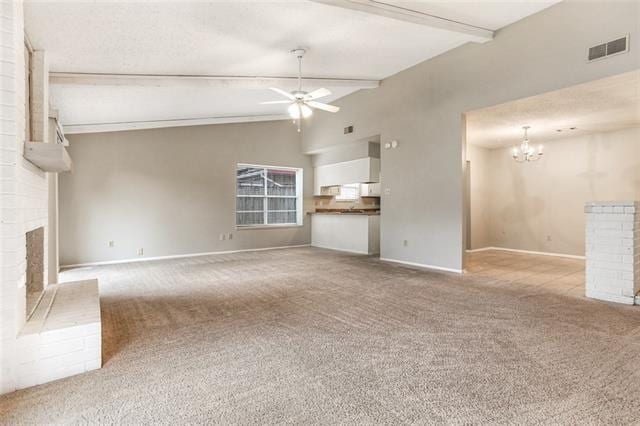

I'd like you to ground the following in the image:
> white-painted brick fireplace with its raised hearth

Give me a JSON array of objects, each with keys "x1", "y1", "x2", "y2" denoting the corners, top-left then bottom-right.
[{"x1": 0, "y1": 0, "x2": 102, "y2": 394}]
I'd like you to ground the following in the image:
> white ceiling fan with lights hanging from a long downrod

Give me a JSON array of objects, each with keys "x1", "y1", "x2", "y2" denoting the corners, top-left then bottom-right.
[{"x1": 261, "y1": 48, "x2": 340, "y2": 131}]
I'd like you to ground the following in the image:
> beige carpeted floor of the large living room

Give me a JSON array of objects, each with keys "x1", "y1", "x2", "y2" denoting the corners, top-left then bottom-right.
[{"x1": 0, "y1": 248, "x2": 640, "y2": 424}]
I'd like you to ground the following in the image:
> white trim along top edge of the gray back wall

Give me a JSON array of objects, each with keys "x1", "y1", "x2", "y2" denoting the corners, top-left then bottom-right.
[{"x1": 62, "y1": 114, "x2": 291, "y2": 135}]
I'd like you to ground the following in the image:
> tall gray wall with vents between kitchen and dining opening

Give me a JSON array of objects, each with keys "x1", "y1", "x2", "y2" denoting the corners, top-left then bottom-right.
[{"x1": 303, "y1": 1, "x2": 640, "y2": 270}]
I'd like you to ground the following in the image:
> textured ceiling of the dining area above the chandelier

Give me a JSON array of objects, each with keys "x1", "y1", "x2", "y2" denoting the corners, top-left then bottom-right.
[{"x1": 467, "y1": 71, "x2": 640, "y2": 148}]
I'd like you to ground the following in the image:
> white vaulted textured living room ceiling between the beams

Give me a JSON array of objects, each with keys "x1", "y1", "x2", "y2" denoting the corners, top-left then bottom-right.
[{"x1": 25, "y1": 0, "x2": 556, "y2": 124}]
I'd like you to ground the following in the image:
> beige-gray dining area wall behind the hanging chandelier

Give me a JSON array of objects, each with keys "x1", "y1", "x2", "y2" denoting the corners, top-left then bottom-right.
[{"x1": 469, "y1": 128, "x2": 640, "y2": 256}]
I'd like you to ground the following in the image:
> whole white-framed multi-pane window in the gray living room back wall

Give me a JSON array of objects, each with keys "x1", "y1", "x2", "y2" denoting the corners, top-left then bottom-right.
[{"x1": 236, "y1": 164, "x2": 302, "y2": 227}]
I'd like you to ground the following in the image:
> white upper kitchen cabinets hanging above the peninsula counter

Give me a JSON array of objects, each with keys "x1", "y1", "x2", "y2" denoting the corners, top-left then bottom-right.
[{"x1": 314, "y1": 157, "x2": 380, "y2": 195}]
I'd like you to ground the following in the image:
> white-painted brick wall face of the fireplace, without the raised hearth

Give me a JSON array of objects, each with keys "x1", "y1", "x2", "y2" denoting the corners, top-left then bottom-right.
[{"x1": 0, "y1": 0, "x2": 48, "y2": 393}]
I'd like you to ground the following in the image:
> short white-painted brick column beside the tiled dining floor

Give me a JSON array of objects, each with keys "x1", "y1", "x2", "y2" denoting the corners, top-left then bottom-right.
[{"x1": 584, "y1": 201, "x2": 640, "y2": 305}]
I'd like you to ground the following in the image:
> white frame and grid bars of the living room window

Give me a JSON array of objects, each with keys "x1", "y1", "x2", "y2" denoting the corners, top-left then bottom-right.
[{"x1": 234, "y1": 163, "x2": 303, "y2": 230}]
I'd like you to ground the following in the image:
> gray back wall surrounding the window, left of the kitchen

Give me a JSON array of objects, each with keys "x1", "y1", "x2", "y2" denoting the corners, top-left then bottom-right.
[{"x1": 60, "y1": 121, "x2": 313, "y2": 265}]
